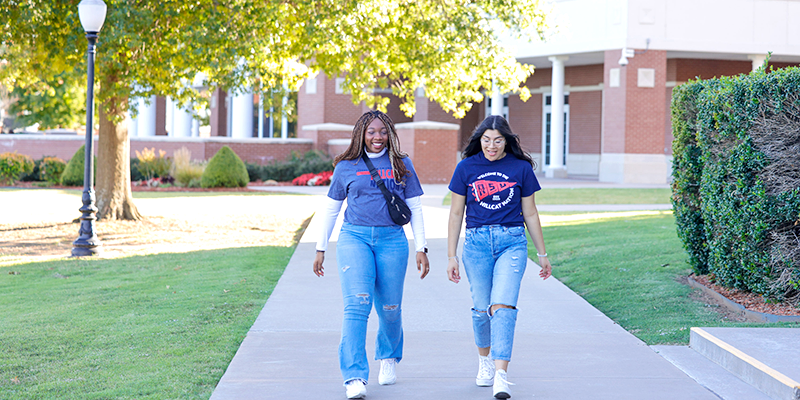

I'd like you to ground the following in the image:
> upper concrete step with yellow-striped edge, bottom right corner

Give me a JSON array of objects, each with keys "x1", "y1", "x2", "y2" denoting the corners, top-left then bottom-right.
[{"x1": 689, "y1": 328, "x2": 800, "y2": 400}]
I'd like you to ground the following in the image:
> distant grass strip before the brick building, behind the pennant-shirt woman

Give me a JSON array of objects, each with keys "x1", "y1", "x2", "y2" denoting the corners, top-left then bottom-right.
[{"x1": 442, "y1": 188, "x2": 672, "y2": 206}]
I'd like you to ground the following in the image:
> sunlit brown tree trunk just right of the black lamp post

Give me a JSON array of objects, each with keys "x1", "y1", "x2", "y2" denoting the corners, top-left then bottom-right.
[{"x1": 96, "y1": 99, "x2": 142, "y2": 221}]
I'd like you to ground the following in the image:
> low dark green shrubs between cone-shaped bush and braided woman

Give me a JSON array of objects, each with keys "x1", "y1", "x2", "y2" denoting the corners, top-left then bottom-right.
[{"x1": 247, "y1": 150, "x2": 333, "y2": 182}]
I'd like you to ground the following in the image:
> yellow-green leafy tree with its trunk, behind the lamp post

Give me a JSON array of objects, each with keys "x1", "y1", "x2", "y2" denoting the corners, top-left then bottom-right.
[{"x1": 0, "y1": 0, "x2": 545, "y2": 219}]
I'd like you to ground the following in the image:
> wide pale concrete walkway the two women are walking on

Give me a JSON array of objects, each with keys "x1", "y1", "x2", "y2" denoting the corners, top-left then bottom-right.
[{"x1": 211, "y1": 185, "x2": 732, "y2": 400}]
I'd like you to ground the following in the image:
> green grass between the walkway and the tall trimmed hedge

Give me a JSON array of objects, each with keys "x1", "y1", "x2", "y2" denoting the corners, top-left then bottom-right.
[{"x1": 528, "y1": 211, "x2": 800, "y2": 345}]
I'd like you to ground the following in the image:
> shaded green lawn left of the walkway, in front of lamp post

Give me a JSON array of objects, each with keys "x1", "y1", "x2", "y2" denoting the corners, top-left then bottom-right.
[{"x1": 0, "y1": 246, "x2": 294, "y2": 399}]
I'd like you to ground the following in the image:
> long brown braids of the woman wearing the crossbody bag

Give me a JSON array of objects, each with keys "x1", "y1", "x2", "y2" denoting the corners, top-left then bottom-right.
[{"x1": 333, "y1": 110, "x2": 409, "y2": 182}]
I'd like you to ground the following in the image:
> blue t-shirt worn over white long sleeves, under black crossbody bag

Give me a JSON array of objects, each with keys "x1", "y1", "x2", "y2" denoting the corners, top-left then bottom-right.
[{"x1": 328, "y1": 153, "x2": 422, "y2": 226}]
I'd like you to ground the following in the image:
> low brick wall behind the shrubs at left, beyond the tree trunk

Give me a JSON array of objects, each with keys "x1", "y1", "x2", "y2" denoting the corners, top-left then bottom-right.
[{"x1": 0, "y1": 134, "x2": 313, "y2": 165}]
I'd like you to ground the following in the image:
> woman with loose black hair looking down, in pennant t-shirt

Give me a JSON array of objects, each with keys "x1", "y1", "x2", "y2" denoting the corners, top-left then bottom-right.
[{"x1": 447, "y1": 115, "x2": 551, "y2": 399}]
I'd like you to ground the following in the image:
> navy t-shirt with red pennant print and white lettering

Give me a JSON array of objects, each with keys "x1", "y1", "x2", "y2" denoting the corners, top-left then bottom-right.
[{"x1": 449, "y1": 152, "x2": 542, "y2": 228}]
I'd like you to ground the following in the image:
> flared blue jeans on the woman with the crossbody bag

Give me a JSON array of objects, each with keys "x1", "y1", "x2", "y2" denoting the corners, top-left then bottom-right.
[{"x1": 336, "y1": 223, "x2": 408, "y2": 383}]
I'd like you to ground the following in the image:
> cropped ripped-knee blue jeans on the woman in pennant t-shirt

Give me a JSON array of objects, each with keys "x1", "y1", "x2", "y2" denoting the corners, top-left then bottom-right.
[{"x1": 462, "y1": 225, "x2": 528, "y2": 361}]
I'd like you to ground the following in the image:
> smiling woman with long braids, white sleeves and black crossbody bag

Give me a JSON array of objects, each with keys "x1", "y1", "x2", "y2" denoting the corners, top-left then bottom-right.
[{"x1": 314, "y1": 111, "x2": 429, "y2": 399}]
